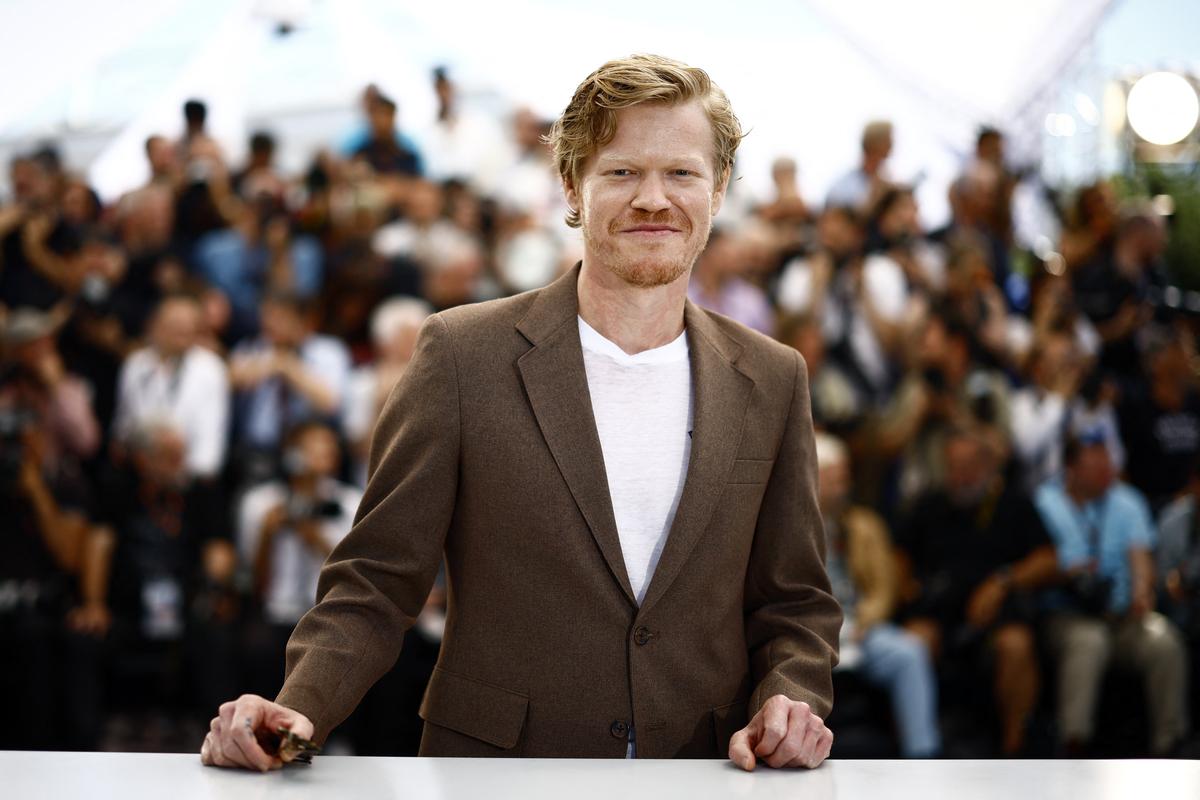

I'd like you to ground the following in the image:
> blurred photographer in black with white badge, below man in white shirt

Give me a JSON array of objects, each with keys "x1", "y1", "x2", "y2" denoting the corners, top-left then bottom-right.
[{"x1": 100, "y1": 417, "x2": 238, "y2": 746}]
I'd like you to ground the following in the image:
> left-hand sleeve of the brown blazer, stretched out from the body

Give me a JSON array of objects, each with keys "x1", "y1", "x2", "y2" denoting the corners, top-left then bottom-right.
[{"x1": 276, "y1": 315, "x2": 461, "y2": 742}]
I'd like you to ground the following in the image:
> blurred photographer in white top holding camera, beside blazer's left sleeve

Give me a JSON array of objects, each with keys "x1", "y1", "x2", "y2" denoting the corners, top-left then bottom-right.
[{"x1": 238, "y1": 422, "x2": 361, "y2": 697}]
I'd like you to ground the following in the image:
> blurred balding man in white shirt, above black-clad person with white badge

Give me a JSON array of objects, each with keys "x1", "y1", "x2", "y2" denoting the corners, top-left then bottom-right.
[{"x1": 113, "y1": 295, "x2": 229, "y2": 479}]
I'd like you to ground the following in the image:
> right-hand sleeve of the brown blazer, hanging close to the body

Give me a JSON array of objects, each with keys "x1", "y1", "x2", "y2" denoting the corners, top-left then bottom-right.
[{"x1": 744, "y1": 354, "x2": 842, "y2": 718}]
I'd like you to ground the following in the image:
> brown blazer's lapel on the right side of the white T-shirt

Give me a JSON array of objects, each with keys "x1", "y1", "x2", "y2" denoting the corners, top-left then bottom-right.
[{"x1": 643, "y1": 300, "x2": 754, "y2": 610}]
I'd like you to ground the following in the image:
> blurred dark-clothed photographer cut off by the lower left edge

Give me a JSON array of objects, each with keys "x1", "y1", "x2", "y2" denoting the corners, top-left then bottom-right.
[{"x1": 0, "y1": 333, "x2": 108, "y2": 750}]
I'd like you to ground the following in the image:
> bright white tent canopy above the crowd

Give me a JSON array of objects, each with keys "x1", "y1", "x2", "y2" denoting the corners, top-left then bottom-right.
[{"x1": 0, "y1": 0, "x2": 1137, "y2": 221}]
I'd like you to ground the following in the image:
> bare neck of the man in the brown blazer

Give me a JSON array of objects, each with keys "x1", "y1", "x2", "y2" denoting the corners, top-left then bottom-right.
[{"x1": 577, "y1": 258, "x2": 690, "y2": 355}]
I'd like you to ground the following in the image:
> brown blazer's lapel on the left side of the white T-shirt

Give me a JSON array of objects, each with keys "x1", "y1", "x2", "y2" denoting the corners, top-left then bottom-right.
[{"x1": 517, "y1": 266, "x2": 637, "y2": 606}]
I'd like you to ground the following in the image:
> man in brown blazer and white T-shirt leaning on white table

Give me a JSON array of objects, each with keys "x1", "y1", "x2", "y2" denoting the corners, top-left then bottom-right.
[{"x1": 202, "y1": 56, "x2": 841, "y2": 770}]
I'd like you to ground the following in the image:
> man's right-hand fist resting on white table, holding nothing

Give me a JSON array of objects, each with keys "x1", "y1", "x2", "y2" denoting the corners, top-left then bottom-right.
[{"x1": 730, "y1": 694, "x2": 833, "y2": 772}]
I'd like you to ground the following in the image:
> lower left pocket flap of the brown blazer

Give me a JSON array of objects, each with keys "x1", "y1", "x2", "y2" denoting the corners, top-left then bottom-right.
[{"x1": 420, "y1": 667, "x2": 529, "y2": 750}]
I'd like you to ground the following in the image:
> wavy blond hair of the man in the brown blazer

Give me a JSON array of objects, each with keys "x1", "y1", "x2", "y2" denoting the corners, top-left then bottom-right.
[{"x1": 546, "y1": 55, "x2": 743, "y2": 228}]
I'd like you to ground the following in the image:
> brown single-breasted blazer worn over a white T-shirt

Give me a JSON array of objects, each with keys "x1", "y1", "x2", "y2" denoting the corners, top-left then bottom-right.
[{"x1": 278, "y1": 267, "x2": 841, "y2": 758}]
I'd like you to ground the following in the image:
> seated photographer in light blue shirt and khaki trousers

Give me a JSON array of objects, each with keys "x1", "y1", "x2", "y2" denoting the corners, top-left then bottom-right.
[{"x1": 1037, "y1": 432, "x2": 1188, "y2": 756}]
